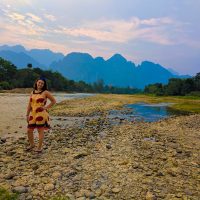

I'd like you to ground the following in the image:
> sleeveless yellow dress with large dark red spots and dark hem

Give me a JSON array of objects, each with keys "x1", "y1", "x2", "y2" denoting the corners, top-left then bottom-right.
[{"x1": 28, "y1": 91, "x2": 50, "y2": 130}]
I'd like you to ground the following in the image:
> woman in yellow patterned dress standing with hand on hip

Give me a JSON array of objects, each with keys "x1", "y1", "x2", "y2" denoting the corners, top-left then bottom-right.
[{"x1": 26, "y1": 77, "x2": 56, "y2": 153}]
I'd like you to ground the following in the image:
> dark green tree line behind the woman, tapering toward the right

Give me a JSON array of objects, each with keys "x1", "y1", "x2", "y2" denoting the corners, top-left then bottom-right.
[{"x1": 0, "y1": 57, "x2": 141, "y2": 94}]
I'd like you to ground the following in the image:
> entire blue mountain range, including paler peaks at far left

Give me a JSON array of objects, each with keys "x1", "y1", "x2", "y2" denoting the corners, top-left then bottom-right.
[{"x1": 0, "y1": 45, "x2": 190, "y2": 89}]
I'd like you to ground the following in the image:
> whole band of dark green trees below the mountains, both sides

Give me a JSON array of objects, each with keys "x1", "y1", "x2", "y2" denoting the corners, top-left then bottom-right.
[{"x1": 0, "y1": 57, "x2": 200, "y2": 96}]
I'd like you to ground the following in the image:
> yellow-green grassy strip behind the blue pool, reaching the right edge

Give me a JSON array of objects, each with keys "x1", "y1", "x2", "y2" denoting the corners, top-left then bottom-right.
[{"x1": 51, "y1": 94, "x2": 200, "y2": 116}]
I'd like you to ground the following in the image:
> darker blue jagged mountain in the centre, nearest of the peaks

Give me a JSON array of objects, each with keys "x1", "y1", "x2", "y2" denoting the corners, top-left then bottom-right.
[{"x1": 50, "y1": 53, "x2": 177, "y2": 88}]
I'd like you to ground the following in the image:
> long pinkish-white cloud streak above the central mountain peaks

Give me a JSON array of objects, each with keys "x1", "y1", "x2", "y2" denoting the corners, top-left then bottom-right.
[{"x1": 54, "y1": 17, "x2": 180, "y2": 45}]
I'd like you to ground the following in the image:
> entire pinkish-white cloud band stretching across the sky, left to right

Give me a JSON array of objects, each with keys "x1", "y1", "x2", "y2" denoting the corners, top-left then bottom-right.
[{"x1": 1, "y1": 7, "x2": 198, "y2": 51}]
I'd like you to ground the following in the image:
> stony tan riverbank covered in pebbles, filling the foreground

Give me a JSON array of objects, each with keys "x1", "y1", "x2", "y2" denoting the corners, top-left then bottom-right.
[{"x1": 0, "y1": 95, "x2": 200, "y2": 200}]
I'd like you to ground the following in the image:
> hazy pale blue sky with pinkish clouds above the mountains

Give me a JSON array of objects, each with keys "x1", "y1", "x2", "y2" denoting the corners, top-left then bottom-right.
[{"x1": 0, "y1": 0, "x2": 200, "y2": 75}]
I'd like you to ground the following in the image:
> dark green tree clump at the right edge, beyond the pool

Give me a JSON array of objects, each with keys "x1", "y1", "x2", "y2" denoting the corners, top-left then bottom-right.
[{"x1": 144, "y1": 72, "x2": 200, "y2": 96}]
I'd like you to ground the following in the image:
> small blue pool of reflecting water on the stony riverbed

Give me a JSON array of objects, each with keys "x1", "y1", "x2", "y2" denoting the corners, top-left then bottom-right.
[{"x1": 109, "y1": 103, "x2": 188, "y2": 122}]
